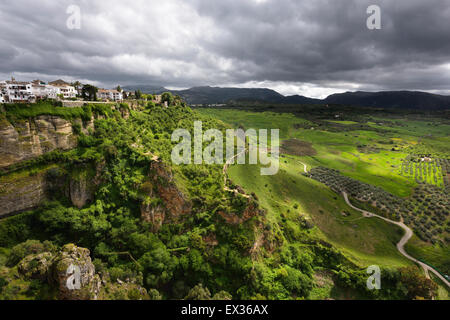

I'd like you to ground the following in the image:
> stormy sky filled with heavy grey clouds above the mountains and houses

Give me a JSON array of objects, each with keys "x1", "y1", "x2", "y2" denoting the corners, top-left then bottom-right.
[{"x1": 0, "y1": 0, "x2": 450, "y2": 97}]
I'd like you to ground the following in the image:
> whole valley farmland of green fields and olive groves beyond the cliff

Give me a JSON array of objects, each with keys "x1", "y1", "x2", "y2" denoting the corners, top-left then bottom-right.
[{"x1": 199, "y1": 108, "x2": 450, "y2": 274}]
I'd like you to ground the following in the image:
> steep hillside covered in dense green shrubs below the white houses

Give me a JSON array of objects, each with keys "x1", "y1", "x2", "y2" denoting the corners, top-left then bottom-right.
[{"x1": 0, "y1": 100, "x2": 440, "y2": 300}]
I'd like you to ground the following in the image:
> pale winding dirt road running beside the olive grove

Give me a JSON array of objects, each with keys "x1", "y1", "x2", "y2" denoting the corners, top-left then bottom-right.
[{"x1": 299, "y1": 161, "x2": 450, "y2": 288}]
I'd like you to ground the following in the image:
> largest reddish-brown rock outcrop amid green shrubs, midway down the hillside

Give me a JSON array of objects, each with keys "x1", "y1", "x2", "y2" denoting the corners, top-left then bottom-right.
[{"x1": 141, "y1": 160, "x2": 192, "y2": 231}]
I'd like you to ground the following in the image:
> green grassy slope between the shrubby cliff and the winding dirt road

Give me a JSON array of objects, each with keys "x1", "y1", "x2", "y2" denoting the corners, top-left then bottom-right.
[{"x1": 229, "y1": 157, "x2": 409, "y2": 267}]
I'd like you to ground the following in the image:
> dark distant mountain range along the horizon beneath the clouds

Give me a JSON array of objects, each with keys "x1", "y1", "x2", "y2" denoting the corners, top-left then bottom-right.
[{"x1": 124, "y1": 86, "x2": 450, "y2": 110}]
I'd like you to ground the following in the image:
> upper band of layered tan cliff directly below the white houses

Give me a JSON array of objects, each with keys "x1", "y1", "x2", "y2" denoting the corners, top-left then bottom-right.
[{"x1": 0, "y1": 115, "x2": 93, "y2": 168}]
